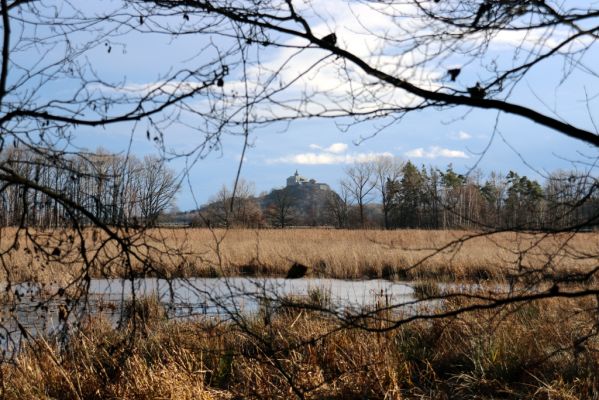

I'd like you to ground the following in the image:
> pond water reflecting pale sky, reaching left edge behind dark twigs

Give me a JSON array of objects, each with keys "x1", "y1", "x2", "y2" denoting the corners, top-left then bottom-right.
[{"x1": 0, "y1": 277, "x2": 426, "y2": 353}]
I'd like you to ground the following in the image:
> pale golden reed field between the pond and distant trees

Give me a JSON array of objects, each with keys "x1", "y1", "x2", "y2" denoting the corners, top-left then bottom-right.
[{"x1": 0, "y1": 228, "x2": 599, "y2": 281}]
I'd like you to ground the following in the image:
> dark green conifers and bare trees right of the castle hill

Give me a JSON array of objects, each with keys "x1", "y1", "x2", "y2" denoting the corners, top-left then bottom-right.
[{"x1": 385, "y1": 162, "x2": 599, "y2": 230}]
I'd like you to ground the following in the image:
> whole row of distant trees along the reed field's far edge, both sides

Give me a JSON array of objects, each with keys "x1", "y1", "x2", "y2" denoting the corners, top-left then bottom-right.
[{"x1": 5, "y1": 148, "x2": 599, "y2": 230}]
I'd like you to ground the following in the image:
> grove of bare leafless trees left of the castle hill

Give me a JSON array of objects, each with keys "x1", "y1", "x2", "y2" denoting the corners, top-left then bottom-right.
[{"x1": 0, "y1": 148, "x2": 179, "y2": 228}]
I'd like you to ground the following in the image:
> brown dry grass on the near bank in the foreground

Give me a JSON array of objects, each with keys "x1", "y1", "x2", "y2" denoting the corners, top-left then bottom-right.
[{"x1": 0, "y1": 299, "x2": 599, "y2": 400}]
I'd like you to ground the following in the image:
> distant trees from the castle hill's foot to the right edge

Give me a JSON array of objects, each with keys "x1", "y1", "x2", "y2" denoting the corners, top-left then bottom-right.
[{"x1": 195, "y1": 157, "x2": 599, "y2": 230}]
